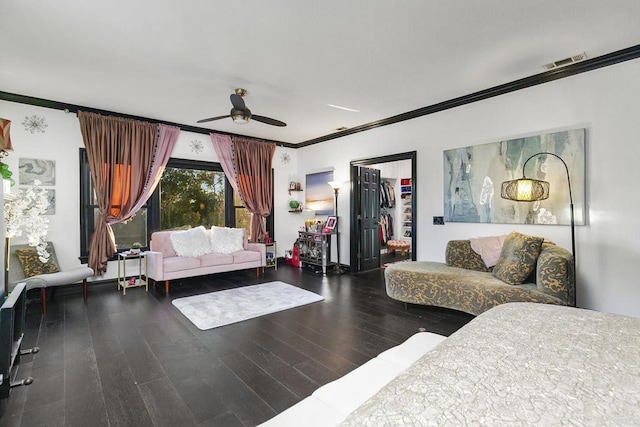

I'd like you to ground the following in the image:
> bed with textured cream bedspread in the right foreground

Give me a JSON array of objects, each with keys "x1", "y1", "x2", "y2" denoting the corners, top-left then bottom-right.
[{"x1": 260, "y1": 303, "x2": 640, "y2": 426}]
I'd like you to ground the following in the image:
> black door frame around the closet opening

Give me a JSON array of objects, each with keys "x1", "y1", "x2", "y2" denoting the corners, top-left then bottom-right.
[{"x1": 349, "y1": 151, "x2": 418, "y2": 273}]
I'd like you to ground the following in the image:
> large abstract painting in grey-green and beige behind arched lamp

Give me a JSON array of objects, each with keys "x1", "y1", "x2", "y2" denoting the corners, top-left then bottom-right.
[{"x1": 444, "y1": 128, "x2": 586, "y2": 225}]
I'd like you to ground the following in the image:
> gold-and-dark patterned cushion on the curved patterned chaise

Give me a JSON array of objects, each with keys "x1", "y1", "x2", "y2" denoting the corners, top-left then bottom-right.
[{"x1": 492, "y1": 231, "x2": 544, "y2": 285}]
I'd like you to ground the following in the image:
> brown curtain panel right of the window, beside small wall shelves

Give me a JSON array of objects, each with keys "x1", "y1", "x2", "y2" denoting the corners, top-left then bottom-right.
[{"x1": 233, "y1": 137, "x2": 276, "y2": 242}]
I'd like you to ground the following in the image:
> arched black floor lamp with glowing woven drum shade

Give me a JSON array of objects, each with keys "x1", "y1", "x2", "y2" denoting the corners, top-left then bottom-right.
[{"x1": 500, "y1": 151, "x2": 578, "y2": 306}]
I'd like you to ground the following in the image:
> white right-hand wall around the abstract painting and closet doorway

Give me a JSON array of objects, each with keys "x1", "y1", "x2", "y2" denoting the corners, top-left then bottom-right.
[{"x1": 298, "y1": 60, "x2": 640, "y2": 317}]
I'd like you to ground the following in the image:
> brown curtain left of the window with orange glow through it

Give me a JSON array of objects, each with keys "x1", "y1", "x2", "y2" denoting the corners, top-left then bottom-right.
[{"x1": 78, "y1": 111, "x2": 158, "y2": 275}]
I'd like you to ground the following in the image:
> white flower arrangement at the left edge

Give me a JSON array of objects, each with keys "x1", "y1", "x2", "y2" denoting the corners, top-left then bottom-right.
[{"x1": 4, "y1": 180, "x2": 49, "y2": 263}]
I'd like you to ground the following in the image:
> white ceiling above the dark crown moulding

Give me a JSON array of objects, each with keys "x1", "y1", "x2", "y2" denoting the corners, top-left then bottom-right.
[{"x1": 0, "y1": 0, "x2": 640, "y2": 143}]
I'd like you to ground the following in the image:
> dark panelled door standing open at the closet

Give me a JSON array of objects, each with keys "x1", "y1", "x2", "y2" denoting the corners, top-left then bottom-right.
[{"x1": 358, "y1": 167, "x2": 380, "y2": 271}]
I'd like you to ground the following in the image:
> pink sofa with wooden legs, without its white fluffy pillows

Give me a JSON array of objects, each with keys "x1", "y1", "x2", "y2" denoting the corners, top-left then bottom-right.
[{"x1": 147, "y1": 230, "x2": 266, "y2": 294}]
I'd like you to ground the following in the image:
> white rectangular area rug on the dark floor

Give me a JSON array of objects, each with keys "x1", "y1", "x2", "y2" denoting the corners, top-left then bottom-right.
[{"x1": 172, "y1": 282, "x2": 324, "y2": 330}]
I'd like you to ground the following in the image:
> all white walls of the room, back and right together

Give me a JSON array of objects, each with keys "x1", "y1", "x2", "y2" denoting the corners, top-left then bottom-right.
[{"x1": 5, "y1": 60, "x2": 640, "y2": 317}]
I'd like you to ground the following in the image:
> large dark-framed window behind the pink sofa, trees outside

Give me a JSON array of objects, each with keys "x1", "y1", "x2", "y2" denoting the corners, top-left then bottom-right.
[{"x1": 80, "y1": 148, "x2": 273, "y2": 262}]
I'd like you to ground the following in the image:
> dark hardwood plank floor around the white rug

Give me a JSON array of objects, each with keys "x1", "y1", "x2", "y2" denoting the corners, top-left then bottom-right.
[{"x1": 0, "y1": 265, "x2": 473, "y2": 427}]
